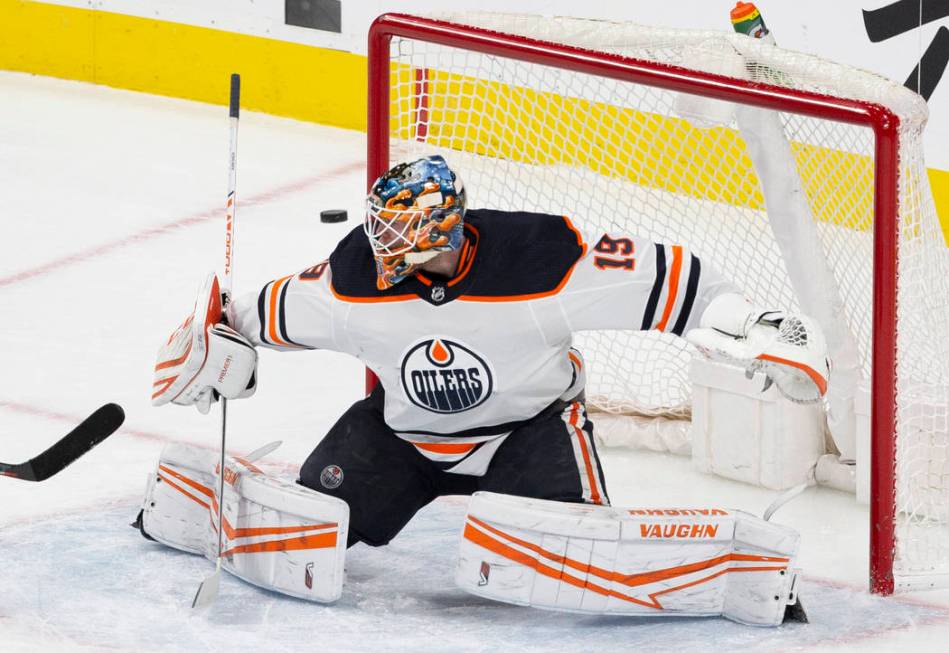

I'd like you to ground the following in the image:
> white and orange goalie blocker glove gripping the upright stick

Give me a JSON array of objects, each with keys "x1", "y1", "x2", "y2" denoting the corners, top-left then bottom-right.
[{"x1": 152, "y1": 274, "x2": 257, "y2": 413}]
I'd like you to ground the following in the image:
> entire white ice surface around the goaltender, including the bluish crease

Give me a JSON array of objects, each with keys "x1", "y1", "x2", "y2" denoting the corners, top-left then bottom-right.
[{"x1": 0, "y1": 73, "x2": 949, "y2": 653}]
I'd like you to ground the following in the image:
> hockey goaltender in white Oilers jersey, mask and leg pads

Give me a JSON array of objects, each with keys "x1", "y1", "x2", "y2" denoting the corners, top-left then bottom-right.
[{"x1": 138, "y1": 156, "x2": 829, "y2": 625}]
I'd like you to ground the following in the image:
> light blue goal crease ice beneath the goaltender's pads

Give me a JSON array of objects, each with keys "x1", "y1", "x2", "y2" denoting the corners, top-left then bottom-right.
[{"x1": 0, "y1": 497, "x2": 949, "y2": 652}]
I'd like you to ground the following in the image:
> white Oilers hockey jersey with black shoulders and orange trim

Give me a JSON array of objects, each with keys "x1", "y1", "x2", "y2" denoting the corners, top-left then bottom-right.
[{"x1": 229, "y1": 209, "x2": 735, "y2": 475}]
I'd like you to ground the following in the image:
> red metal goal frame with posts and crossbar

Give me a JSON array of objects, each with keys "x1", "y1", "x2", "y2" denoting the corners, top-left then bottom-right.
[{"x1": 367, "y1": 14, "x2": 920, "y2": 594}]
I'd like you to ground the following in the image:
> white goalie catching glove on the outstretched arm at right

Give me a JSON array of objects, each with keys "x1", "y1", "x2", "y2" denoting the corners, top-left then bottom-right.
[{"x1": 686, "y1": 293, "x2": 830, "y2": 403}]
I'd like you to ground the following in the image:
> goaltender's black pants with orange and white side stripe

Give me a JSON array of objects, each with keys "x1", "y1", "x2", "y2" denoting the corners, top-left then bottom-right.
[{"x1": 299, "y1": 387, "x2": 609, "y2": 546}]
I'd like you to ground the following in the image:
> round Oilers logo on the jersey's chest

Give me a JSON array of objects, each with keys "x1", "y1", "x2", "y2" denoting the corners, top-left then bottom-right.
[{"x1": 402, "y1": 338, "x2": 494, "y2": 413}]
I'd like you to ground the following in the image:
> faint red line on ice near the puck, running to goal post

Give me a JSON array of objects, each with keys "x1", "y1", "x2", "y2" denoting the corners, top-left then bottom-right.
[{"x1": 0, "y1": 161, "x2": 366, "y2": 288}]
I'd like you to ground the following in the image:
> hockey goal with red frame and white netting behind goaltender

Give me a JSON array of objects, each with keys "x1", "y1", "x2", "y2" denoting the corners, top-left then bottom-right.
[{"x1": 368, "y1": 13, "x2": 949, "y2": 594}]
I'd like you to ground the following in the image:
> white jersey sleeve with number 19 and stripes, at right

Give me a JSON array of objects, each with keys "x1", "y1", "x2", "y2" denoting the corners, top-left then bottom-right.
[{"x1": 559, "y1": 234, "x2": 738, "y2": 336}]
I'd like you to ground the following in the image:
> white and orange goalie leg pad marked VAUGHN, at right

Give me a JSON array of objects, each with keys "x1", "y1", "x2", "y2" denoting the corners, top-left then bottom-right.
[{"x1": 455, "y1": 492, "x2": 799, "y2": 626}]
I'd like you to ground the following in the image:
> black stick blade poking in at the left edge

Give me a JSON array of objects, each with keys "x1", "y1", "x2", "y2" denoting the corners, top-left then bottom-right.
[{"x1": 0, "y1": 404, "x2": 125, "y2": 481}]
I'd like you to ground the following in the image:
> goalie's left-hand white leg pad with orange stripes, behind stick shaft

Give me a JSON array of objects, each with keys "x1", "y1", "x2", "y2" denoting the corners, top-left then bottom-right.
[{"x1": 141, "y1": 444, "x2": 349, "y2": 602}]
